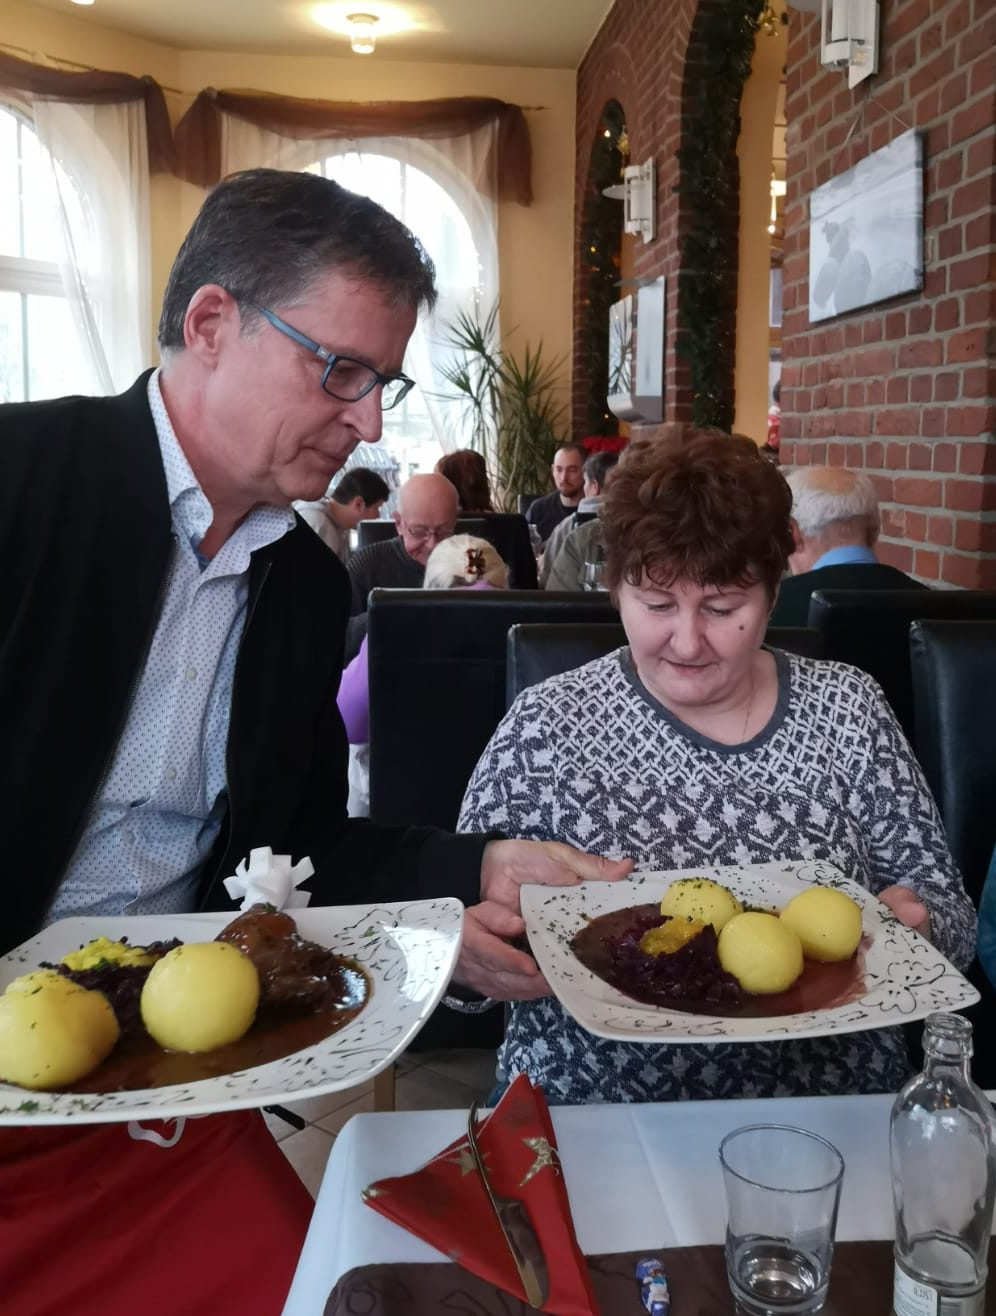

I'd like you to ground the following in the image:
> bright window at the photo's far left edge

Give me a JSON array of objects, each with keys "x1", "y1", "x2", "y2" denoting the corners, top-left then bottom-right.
[{"x1": 0, "y1": 105, "x2": 93, "y2": 403}]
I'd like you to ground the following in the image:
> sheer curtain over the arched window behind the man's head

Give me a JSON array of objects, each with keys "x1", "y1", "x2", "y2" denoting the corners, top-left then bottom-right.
[{"x1": 221, "y1": 114, "x2": 499, "y2": 453}]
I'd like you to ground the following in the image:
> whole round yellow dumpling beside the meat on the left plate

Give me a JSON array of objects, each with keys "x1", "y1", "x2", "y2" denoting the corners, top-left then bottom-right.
[{"x1": 141, "y1": 941, "x2": 259, "y2": 1051}]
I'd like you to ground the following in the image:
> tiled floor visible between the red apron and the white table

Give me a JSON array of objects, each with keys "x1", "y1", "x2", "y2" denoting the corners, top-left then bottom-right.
[{"x1": 266, "y1": 1050, "x2": 495, "y2": 1195}]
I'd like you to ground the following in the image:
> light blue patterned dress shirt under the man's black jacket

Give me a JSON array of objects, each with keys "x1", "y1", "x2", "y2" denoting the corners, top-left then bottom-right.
[{"x1": 49, "y1": 371, "x2": 295, "y2": 923}]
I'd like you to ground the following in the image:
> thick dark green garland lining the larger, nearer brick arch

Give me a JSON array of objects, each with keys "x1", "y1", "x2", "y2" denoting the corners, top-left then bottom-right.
[{"x1": 676, "y1": 0, "x2": 763, "y2": 430}]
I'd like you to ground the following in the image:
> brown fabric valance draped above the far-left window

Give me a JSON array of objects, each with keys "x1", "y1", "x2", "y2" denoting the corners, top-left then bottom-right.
[{"x1": 0, "y1": 53, "x2": 174, "y2": 174}]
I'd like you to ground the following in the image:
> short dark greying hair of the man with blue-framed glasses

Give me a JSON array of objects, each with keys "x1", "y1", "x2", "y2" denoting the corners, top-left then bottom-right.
[{"x1": 159, "y1": 168, "x2": 436, "y2": 353}]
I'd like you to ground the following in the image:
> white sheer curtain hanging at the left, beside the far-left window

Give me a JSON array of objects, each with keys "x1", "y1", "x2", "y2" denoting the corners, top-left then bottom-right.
[{"x1": 30, "y1": 97, "x2": 151, "y2": 393}]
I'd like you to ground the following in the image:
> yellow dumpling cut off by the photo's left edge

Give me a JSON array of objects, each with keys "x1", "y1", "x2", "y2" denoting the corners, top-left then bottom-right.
[{"x1": 0, "y1": 970, "x2": 120, "y2": 1091}]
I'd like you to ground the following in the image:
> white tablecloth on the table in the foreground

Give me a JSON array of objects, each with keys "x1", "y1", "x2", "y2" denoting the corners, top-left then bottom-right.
[{"x1": 284, "y1": 1096, "x2": 893, "y2": 1316}]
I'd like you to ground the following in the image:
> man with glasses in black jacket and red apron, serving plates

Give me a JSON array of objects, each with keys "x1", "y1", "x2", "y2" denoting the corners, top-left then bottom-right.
[{"x1": 0, "y1": 170, "x2": 628, "y2": 1316}]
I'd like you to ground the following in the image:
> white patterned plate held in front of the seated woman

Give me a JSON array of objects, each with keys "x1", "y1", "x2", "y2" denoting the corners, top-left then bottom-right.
[{"x1": 522, "y1": 859, "x2": 979, "y2": 1042}]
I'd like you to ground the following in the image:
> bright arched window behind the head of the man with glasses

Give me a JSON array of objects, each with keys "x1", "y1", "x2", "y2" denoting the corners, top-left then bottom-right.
[{"x1": 309, "y1": 143, "x2": 493, "y2": 483}]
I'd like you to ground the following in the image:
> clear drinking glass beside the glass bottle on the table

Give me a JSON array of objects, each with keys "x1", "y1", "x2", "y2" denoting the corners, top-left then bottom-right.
[{"x1": 720, "y1": 1124, "x2": 843, "y2": 1316}]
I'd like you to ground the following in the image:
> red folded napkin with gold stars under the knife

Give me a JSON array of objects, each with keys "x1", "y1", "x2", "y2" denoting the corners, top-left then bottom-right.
[{"x1": 363, "y1": 1074, "x2": 599, "y2": 1316}]
